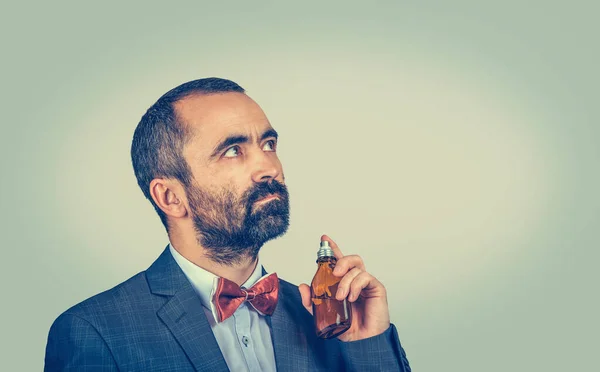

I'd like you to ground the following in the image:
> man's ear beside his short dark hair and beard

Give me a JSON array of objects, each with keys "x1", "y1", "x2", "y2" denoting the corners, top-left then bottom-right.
[{"x1": 150, "y1": 178, "x2": 188, "y2": 218}]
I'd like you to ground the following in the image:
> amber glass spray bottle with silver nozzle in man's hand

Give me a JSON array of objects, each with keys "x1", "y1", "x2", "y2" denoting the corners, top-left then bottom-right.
[{"x1": 310, "y1": 241, "x2": 352, "y2": 338}]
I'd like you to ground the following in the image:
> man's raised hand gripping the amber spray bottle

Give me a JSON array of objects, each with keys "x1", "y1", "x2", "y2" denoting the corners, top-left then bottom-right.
[{"x1": 298, "y1": 235, "x2": 390, "y2": 341}]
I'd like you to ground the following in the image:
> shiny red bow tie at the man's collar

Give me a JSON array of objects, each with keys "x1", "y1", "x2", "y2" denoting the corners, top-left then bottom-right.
[{"x1": 213, "y1": 273, "x2": 279, "y2": 322}]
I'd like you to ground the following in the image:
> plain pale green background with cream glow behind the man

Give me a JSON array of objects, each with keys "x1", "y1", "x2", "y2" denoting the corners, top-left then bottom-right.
[{"x1": 0, "y1": 1, "x2": 600, "y2": 372}]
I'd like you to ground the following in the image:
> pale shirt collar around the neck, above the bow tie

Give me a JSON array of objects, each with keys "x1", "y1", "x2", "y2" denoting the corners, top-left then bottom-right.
[{"x1": 169, "y1": 244, "x2": 263, "y2": 319}]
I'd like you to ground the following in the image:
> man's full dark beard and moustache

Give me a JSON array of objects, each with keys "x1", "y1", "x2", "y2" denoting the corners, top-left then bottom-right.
[{"x1": 186, "y1": 180, "x2": 290, "y2": 265}]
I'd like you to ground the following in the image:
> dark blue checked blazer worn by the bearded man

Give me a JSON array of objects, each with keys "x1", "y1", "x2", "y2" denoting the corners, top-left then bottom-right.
[{"x1": 44, "y1": 246, "x2": 410, "y2": 372}]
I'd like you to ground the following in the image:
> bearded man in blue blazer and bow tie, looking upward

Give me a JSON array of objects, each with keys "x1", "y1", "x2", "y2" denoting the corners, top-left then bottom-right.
[{"x1": 44, "y1": 78, "x2": 410, "y2": 372}]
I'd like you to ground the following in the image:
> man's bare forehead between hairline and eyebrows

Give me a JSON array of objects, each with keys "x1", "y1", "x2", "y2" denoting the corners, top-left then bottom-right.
[{"x1": 174, "y1": 92, "x2": 271, "y2": 152}]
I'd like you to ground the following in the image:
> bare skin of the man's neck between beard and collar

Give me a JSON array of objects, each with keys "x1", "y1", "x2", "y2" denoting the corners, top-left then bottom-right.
[{"x1": 168, "y1": 227, "x2": 258, "y2": 286}]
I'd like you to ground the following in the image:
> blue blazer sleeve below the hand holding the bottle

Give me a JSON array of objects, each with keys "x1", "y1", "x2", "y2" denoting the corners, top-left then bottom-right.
[{"x1": 338, "y1": 324, "x2": 411, "y2": 372}]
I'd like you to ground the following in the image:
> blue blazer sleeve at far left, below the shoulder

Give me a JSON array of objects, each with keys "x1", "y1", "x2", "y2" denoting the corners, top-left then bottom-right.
[{"x1": 44, "y1": 314, "x2": 119, "y2": 372}]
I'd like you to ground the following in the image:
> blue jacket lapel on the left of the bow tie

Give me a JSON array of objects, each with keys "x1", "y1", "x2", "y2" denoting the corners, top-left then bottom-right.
[{"x1": 146, "y1": 246, "x2": 228, "y2": 372}]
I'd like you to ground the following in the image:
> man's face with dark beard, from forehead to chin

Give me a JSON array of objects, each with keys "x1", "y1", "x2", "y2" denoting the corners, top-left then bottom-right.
[{"x1": 175, "y1": 93, "x2": 289, "y2": 264}]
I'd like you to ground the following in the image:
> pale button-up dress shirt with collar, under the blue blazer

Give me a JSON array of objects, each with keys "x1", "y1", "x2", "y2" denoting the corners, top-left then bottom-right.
[{"x1": 169, "y1": 244, "x2": 276, "y2": 372}]
